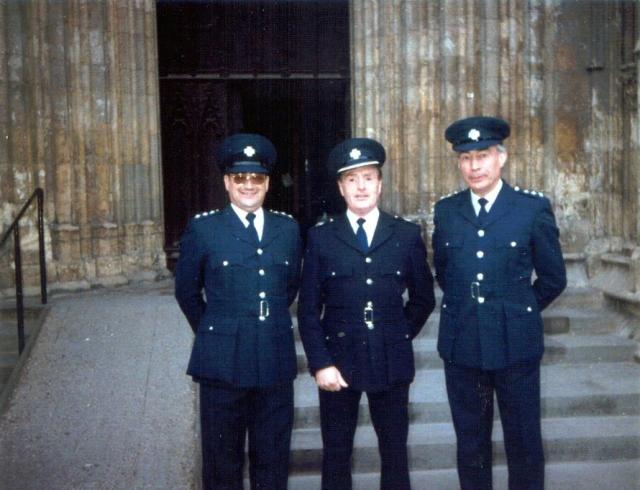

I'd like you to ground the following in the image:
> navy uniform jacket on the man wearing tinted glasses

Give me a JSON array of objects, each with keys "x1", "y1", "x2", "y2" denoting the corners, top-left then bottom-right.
[{"x1": 175, "y1": 206, "x2": 301, "y2": 387}]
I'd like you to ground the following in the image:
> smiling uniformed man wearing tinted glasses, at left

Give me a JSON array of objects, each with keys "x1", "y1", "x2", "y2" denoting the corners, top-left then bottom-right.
[{"x1": 176, "y1": 134, "x2": 301, "y2": 490}]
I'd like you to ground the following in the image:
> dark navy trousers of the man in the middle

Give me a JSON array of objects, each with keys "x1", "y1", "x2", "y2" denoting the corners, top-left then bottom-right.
[{"x1": 319, "y1": 384, "x2": 410, "y2": 490}]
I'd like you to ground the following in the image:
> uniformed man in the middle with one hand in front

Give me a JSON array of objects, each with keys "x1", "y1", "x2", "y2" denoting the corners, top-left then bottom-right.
[{"x1": 298, "y1": 138, "x2": 435, "y2": 490}]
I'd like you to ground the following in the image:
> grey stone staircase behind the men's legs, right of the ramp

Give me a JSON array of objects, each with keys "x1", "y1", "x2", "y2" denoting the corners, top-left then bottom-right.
[{"x1": 289, "y1": 290, "x2": 640, "y2": 490}]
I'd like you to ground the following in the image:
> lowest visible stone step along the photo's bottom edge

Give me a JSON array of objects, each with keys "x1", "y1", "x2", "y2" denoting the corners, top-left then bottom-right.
[{"x1": 288, "y1": 460, "x2": 640, "y2": 490}]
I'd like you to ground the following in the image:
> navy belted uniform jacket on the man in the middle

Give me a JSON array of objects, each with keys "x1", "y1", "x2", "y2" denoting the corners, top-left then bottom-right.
[{"x1": 298, "y1": 212, "x2": 435, "y2": 391}]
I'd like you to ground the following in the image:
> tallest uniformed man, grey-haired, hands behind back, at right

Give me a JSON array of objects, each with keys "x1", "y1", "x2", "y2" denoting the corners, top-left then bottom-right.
[{"x1": 433, "y1": 117, "x2": 566, "y2": 490}]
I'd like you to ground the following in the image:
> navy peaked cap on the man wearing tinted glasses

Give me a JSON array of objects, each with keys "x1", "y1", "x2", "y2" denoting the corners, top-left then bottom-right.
[{"x1": 216, "y1": 133, "x2": 277, "y2": 174}]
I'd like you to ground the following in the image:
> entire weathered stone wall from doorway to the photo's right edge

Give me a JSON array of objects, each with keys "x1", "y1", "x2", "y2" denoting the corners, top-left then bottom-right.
[{"x1": 351, "y1": 0, "x2": 640, "y2": 254}]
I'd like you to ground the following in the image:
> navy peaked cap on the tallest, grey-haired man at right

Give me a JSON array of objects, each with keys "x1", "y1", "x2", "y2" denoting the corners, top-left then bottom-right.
[{"x1": 444, "y1": 116, "x2": 510, "y2": 152}]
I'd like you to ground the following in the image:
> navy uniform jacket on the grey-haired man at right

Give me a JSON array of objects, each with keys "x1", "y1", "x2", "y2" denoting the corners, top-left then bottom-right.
[{"x1": 433, "y1": 183, "x2": 566, "y2": 369}]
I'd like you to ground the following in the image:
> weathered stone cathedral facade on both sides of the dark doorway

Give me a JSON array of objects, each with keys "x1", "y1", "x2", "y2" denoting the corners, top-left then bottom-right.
[{"x1": 0, "y1": 0, "x2": 640, "y2": 306}]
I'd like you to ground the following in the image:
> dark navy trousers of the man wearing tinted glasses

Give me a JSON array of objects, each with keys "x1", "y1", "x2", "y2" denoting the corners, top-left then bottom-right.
[{"x1": 200, "y1": 381, "x2": 293, "y2": 490}]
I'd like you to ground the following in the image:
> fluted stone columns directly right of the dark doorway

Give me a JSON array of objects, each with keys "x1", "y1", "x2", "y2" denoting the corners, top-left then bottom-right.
[{"x1": 352, "y1": 0, "x2": 553, "y2": 228}]
